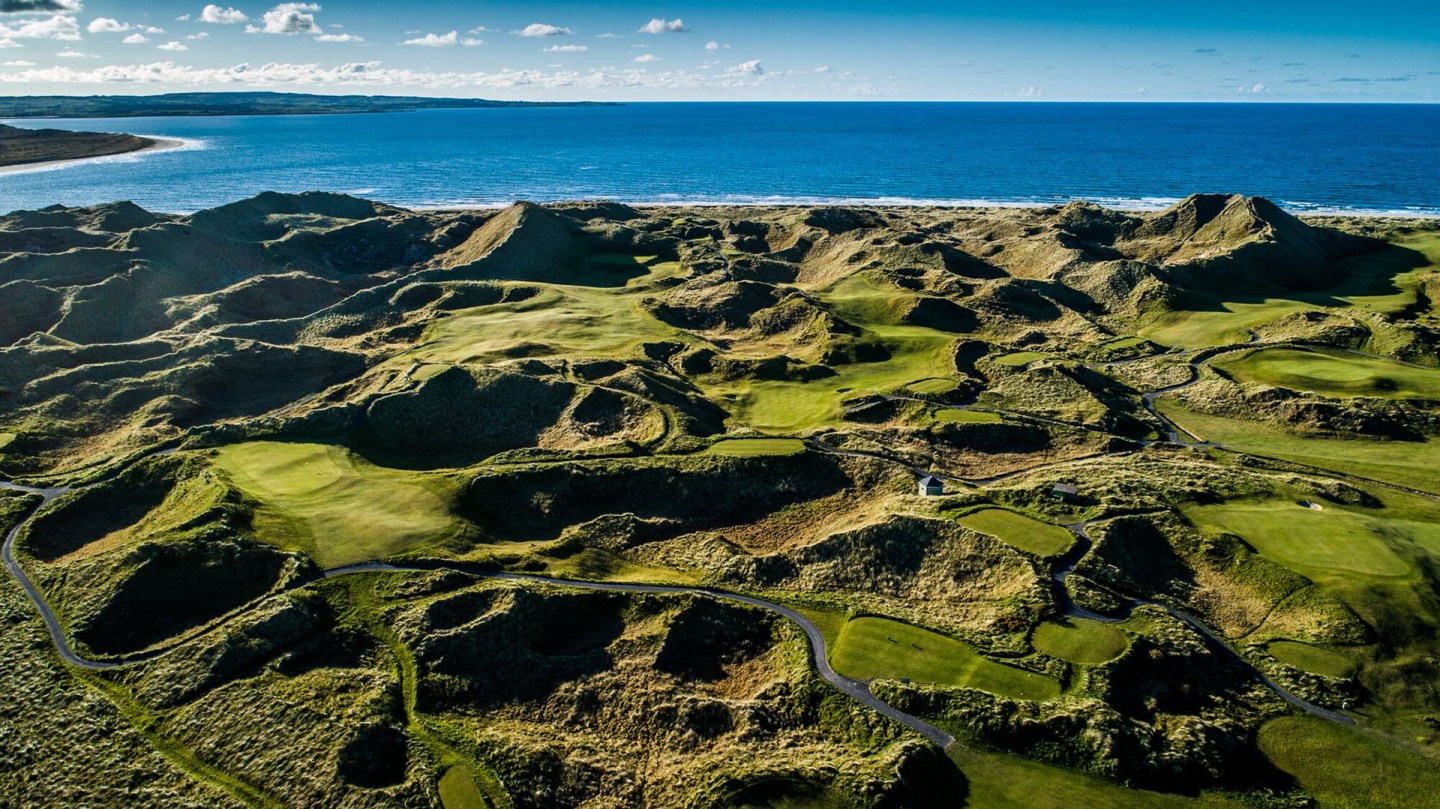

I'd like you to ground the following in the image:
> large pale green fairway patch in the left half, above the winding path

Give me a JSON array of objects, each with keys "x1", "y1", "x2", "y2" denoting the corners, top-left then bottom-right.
[{"x1": 216, "y1": 442, "x2": 459, "y2": 567}]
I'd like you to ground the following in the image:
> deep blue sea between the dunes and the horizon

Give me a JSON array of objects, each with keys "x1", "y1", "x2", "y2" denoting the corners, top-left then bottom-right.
[{"x1": 0, "y1": 104, "x2": 1440, "y2": 216}]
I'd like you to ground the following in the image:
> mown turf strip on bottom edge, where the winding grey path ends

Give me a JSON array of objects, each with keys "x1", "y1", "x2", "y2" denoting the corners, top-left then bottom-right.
[{"x1": 959, "y1": 753, "x2": 1247, "y2": 809}]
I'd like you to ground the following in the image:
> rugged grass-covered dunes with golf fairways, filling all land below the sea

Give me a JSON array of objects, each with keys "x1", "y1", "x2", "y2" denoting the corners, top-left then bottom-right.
[{"x1": 0, "y1": 193, "x2": 1440, "y2": 809}]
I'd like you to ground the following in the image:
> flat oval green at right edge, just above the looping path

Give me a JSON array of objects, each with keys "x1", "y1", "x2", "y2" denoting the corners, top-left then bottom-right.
[{"x1": 1215, "y1": 348, "x2": 1440, "y2": 399}]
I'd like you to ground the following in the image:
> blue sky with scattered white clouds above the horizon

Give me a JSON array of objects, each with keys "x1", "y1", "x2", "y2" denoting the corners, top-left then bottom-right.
[{"x1": 0, "y1": 0, "x2": 1440, "y2": 102}]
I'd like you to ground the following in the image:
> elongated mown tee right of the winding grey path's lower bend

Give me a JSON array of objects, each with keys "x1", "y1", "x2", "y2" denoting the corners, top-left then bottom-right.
[{"x1": 829, "y1": 618, "x2": 1060, "y2": 700}]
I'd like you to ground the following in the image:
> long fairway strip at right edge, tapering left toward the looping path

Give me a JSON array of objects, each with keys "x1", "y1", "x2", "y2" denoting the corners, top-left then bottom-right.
[{"x1": 1155, "y1": 397, "x2": 1440, "y2": 494}]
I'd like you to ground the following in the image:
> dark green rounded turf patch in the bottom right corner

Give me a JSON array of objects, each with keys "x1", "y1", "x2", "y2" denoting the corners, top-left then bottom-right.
[{"x1": 1260, "y1": 717, "x2": 1440, "y2": 809}]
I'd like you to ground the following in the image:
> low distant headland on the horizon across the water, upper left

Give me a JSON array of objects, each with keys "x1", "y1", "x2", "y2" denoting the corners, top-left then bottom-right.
[{"x1": 0, "y1": 92, "x2": 613, "y2": 118}]
